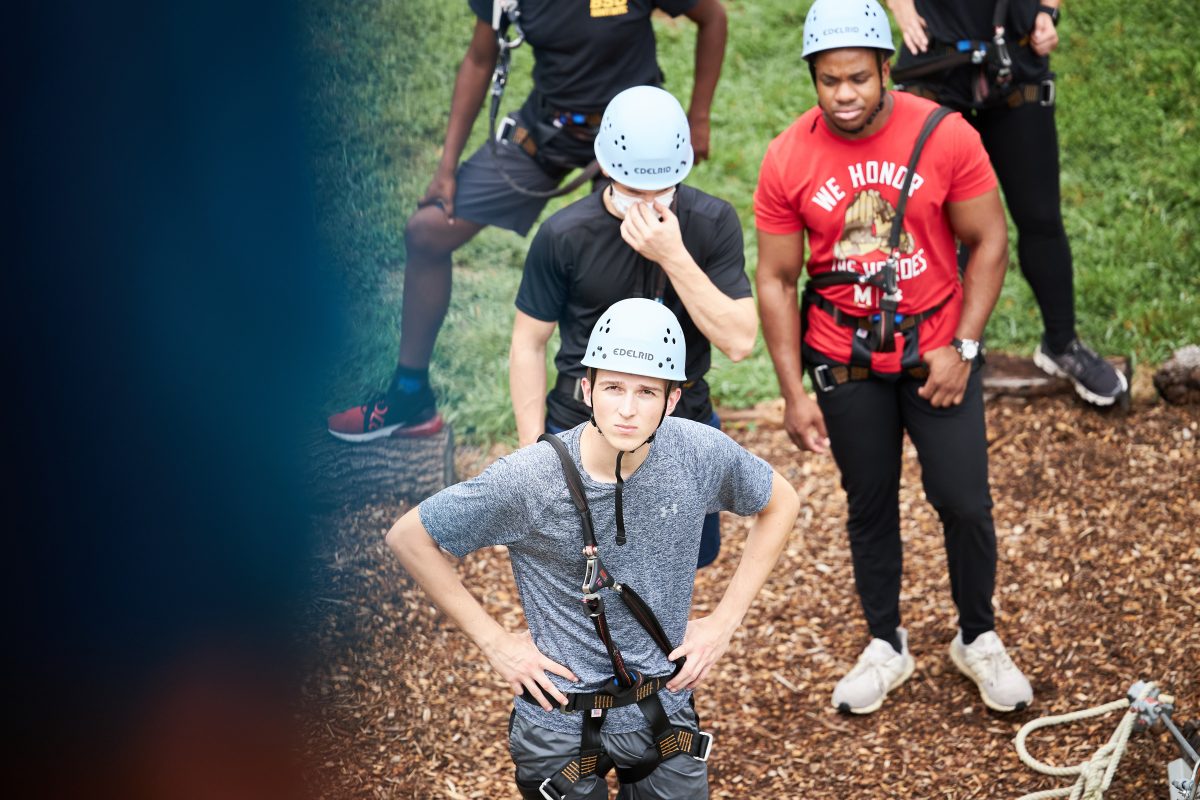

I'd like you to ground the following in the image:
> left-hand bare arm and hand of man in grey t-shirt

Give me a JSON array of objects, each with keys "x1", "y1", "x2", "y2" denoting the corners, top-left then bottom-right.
[{"x1": 386, "y1": 509, "x2": 578, "y2": 711}]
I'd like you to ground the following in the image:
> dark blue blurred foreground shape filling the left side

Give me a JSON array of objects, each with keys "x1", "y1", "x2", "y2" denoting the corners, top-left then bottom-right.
[{"x1": 0, "y1": 0, "x2": 340, "y2": 800}]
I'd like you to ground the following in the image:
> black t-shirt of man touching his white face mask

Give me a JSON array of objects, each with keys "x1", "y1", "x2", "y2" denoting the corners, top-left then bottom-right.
[{"x1": 516, "y1": 186, "x2": 751, "y2": 427}]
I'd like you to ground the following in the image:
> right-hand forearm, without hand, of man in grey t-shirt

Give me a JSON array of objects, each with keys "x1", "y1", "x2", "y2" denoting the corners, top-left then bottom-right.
[{"x1": 713, "y1": 473, "x2": 800, "y2": 631}]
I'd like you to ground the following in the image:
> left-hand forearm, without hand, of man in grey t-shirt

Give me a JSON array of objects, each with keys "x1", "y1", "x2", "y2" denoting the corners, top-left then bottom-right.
[{"x1": 386, "y1": 509, "x2": 504, "y2": 651}]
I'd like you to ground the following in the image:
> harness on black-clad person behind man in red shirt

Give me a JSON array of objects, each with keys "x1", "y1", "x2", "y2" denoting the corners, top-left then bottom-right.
[{"x1": 892, "y1": 0, "x2": 1055, "y2": 108}]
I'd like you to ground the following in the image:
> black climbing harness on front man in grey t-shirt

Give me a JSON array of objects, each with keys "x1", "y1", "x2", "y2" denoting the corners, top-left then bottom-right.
[{"x1": 518, "y1": 433, "x2": 713, "y2": 800}]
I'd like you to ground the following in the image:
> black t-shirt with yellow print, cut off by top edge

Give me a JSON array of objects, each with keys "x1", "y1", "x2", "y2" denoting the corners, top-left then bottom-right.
[{"x1": 469, "y1": 0, "x2": 697, "y2": 113}]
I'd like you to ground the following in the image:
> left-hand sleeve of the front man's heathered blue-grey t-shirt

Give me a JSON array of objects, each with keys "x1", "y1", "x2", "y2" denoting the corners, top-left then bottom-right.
[{"x1": 418, "y1": 458, "x2": 533, "y2": 558}]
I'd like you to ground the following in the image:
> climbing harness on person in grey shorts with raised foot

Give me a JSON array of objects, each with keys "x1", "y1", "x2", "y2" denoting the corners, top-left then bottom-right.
[{"x1": 487, "y1": 0, "x2": 600, "y2": 198}]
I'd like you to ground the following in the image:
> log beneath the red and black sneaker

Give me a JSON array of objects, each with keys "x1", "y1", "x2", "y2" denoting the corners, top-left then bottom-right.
[{"x1": 308, "y1": 425, "x2": 456, "y2": 506}]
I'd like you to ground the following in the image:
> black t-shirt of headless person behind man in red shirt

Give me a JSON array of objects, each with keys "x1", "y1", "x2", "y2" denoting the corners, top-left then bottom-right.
[{"x1": 896, "y1": 0, "x2": 1052, "y2": 110}]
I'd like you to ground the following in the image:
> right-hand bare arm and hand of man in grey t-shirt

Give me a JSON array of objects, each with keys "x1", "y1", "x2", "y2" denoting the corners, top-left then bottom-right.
[{"x1": 667, "y1": 473, "x2": 800, "y2": 692}]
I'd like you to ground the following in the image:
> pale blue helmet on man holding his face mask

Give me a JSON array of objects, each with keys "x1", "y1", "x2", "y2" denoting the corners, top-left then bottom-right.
[{"x1": 595, "y1": 86, "x2": 694, "y2": 190}]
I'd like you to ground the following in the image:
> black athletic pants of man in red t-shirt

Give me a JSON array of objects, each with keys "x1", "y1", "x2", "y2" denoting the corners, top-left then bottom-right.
[{"x1": 817, "y1": 357, "x2": 996, "y2": 640}]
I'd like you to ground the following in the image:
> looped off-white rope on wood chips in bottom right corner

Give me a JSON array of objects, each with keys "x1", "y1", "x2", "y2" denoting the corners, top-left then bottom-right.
[{"x1": 1013, "y1": 682, "x2": 1154, "y2": 800}]
